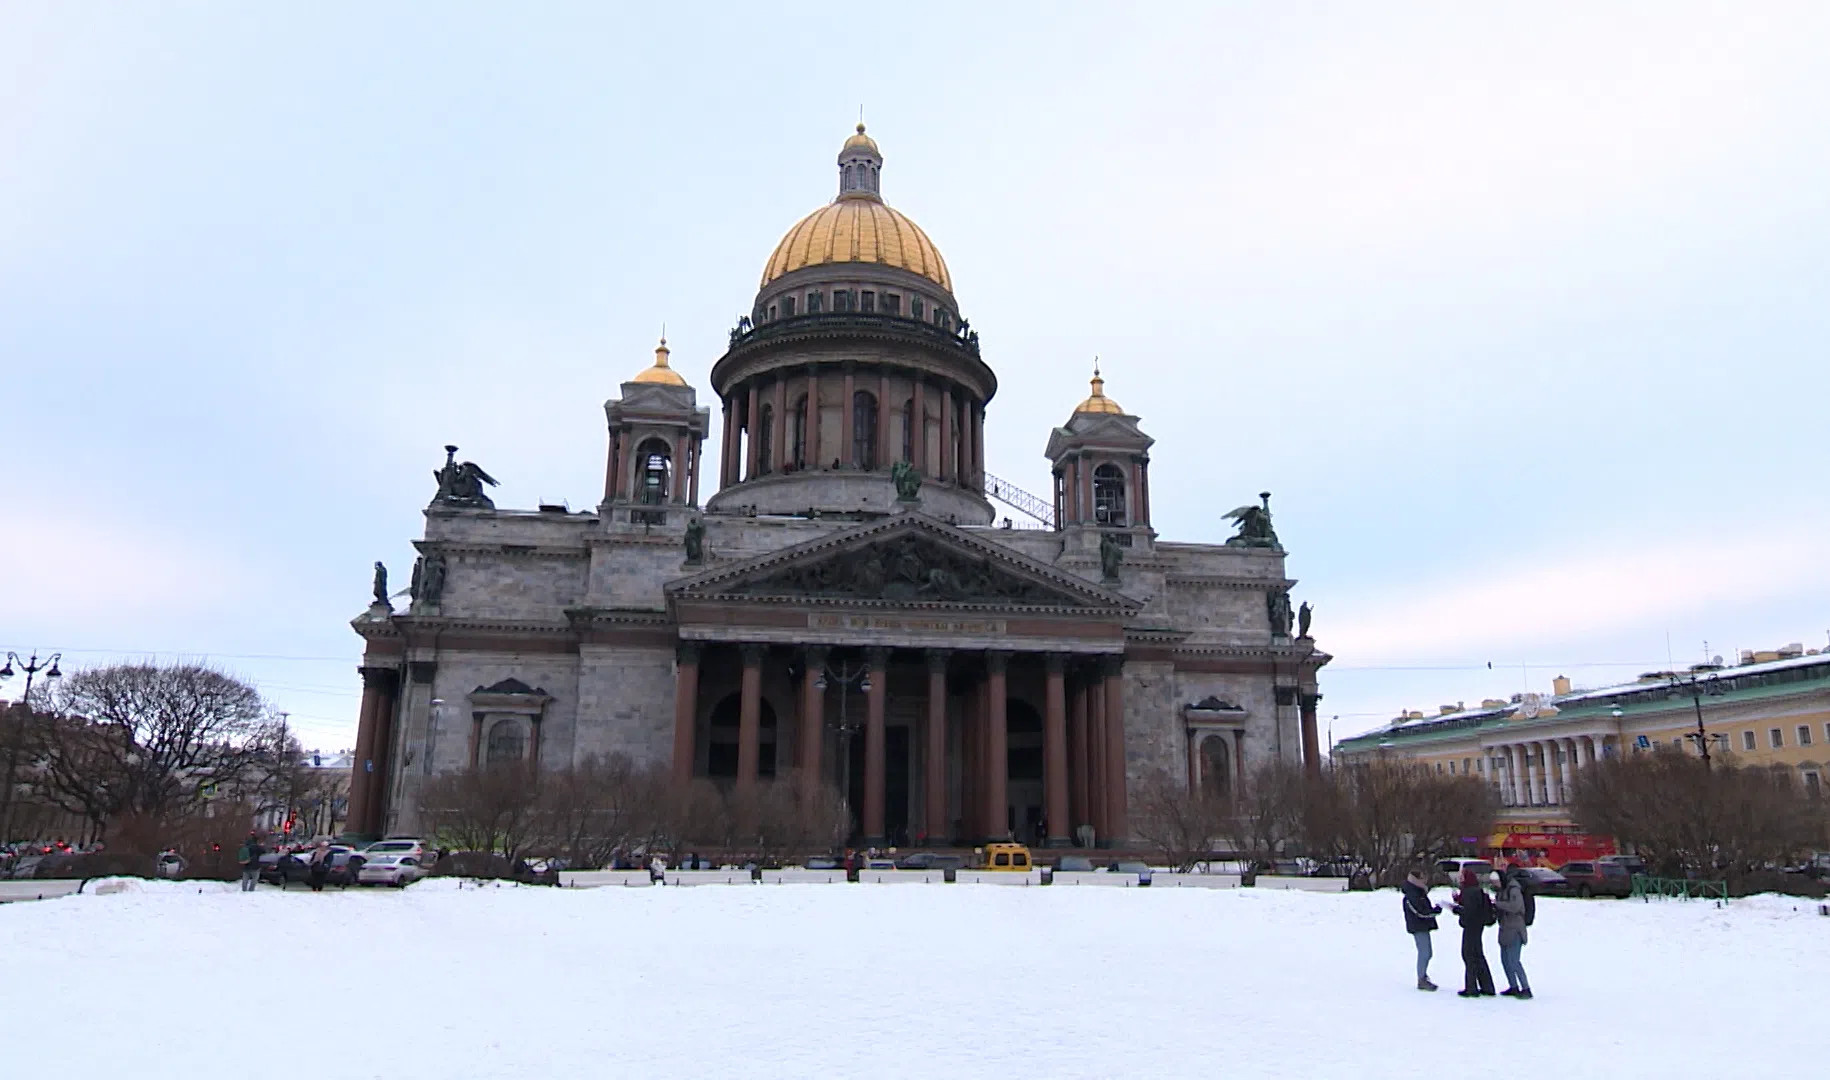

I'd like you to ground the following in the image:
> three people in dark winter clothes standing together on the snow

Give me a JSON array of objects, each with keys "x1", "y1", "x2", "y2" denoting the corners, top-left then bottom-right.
[{"x1": 1404, "y1": 864, "x2": 1534, "y2": 1001}]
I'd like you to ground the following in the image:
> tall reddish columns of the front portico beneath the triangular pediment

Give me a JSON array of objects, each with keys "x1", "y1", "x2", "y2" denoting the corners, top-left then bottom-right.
[{"x1": 673, "y1": 643, "x2": 1129, "y2": 848}]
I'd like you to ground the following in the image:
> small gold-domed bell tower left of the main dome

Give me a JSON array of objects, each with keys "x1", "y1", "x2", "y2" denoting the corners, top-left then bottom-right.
[{"x1": 598, "y1": 337, "x2": 712, "y2": 527}]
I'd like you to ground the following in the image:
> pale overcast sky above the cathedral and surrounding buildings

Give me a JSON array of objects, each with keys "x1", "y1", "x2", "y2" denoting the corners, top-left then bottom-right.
[{"x1": 0, "y1": 0, "x2": 1830, "y2": 749}]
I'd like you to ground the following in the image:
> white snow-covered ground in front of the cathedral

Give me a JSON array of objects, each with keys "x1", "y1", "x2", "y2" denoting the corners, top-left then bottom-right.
[{"x1": 0, "y1": 880, "x2": 1830, "y2": 1080}]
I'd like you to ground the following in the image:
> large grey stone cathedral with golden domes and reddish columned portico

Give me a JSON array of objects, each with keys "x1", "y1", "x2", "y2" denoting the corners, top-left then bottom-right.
[{"x1": 351, "y1": 124, "x2": 1329, "y2": 846}]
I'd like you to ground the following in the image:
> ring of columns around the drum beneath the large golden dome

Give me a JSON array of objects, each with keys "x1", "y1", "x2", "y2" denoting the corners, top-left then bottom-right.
[{"x1": 717, "y1": 364, "x2": 985, "y2": 502}]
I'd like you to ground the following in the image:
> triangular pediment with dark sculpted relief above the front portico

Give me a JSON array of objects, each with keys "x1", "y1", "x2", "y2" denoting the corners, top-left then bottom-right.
[{"x1": 670, "y1": 514, "x2": 1138, "y2": 613}]
